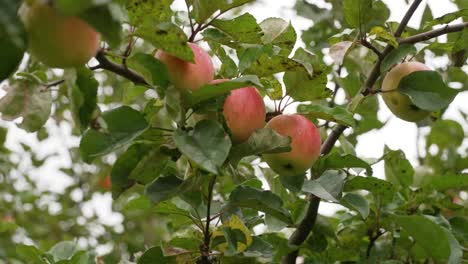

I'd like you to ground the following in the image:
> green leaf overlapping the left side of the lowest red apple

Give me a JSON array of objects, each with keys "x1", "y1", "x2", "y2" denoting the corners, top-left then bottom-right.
[{"x1": 229, "y1": 128, "x2": 291, "y2": 164}]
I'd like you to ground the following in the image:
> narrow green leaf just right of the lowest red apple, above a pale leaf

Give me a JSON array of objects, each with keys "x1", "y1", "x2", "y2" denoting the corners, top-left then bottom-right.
[{"x1": 313, "y1": 152, "x2": 372, "y2": 175}]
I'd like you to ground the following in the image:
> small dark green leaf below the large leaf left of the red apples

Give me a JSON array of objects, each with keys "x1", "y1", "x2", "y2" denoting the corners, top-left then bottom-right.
[{"x1": 145, "y1": 175, "x2": 184, "y2": 205}]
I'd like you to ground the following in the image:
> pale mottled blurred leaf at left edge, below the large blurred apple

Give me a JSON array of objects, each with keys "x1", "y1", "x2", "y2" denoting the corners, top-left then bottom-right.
[{"x1": 0, "y1": 80, "x2": 52, "y2": 132}]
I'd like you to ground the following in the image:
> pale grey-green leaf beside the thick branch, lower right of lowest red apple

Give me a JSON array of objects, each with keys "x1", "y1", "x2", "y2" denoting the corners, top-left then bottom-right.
[{"x1": 302, "y1": 171, "x2": 346, "y2": 202}]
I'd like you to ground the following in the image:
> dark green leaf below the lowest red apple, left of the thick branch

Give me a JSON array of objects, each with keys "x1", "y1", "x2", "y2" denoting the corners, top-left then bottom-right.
[{"x1": 229, "y1": 185, "x2": 292, "y2": 223}]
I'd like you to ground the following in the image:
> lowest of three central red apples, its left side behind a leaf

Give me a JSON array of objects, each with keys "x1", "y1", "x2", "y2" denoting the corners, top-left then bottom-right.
[{"x1": 263, "y1": 114, "x2": 321, "y2": 176}]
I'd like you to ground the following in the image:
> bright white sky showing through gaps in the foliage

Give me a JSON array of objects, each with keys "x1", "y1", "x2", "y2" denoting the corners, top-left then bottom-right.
[{"x1": 0, "y1": 0, "x2": 468, "y2": 248}]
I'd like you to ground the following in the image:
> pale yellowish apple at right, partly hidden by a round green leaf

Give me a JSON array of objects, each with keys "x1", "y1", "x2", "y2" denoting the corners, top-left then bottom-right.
[{"x1": 381, "y1": 62, "x2": 431, "y2": 122}]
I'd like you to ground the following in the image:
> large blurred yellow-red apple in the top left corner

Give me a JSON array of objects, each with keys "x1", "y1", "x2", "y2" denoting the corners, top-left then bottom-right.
[{"x1": 19, "y1": 1, "x2": 100, "y2": 68}]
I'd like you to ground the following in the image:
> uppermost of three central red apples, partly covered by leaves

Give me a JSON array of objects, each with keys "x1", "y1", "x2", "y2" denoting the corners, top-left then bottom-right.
[{"x1": 155, "y1": 43, "x2": 214, "y2": 91}]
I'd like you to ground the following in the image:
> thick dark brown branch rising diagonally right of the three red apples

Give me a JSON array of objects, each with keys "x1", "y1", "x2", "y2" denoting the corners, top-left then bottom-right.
[{"x1": 283, "y1": 0, "x2": 422, "y2": 264}]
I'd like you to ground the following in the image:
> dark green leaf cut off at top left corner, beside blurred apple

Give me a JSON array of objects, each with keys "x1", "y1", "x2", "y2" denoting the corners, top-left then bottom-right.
[{"x1": 0, "y1": 0, "x2": 27, "y2": 82}]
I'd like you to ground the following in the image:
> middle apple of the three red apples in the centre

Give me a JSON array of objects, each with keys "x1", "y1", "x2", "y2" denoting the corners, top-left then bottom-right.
[{"x1": 215, "y1": 80, "x2": 266, "y2": 143}]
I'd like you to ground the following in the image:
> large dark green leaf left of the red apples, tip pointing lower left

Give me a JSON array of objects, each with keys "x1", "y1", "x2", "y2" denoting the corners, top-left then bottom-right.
[{"x1": 80, "y1": 106, "x2": 148, "y2": 162}]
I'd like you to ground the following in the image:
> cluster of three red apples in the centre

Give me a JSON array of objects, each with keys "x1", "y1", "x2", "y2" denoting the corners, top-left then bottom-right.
[{"x1": 155, "y1": 43, "x2": 321, "y2": 176}]
